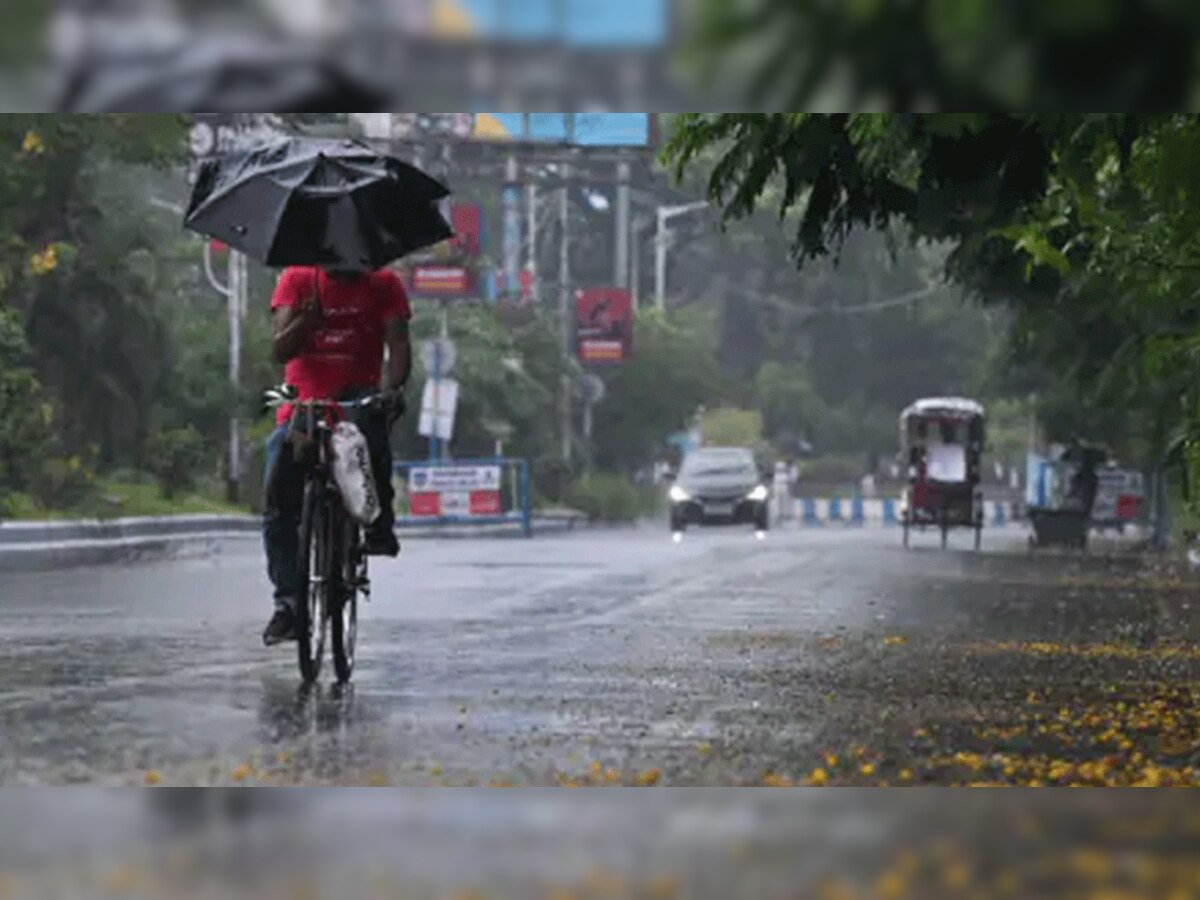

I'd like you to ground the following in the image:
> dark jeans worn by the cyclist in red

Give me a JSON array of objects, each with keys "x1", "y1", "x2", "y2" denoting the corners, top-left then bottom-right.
[{"x1": 263, "y1": 400, "x2": 396, "y2": 606}]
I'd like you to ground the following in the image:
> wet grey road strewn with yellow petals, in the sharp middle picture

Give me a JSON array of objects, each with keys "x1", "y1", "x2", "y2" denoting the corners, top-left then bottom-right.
[{"x1": 0, "y1": 527, "x2": 1200, "y2": 785}]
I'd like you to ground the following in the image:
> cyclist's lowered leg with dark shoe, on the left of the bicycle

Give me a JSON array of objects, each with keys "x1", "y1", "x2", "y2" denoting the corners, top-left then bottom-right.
[{"x1": 263, "y1": 426, "x2": 304, "y2": 644}]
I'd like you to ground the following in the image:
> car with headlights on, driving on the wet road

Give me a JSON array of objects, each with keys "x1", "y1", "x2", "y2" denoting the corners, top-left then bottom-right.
[{"x1": 668, "y1": 446, "x2": 770, "y2": 533}]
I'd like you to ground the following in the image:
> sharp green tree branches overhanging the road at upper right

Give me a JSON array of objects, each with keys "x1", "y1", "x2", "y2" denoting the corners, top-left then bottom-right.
[{"x1": 667, "y1": 114, "x2": 1200, "y2": 472}]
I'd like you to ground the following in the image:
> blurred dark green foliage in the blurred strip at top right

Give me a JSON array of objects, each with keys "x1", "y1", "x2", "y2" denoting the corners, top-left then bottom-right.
[{"x1": 692, "y1": 0, "x2": 1200, "y2": 109}]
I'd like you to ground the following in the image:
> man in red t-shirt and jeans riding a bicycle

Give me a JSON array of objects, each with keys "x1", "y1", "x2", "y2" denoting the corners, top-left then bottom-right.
[{"x1": 263, "y1": 266, "x2": 413, "y2": 646}]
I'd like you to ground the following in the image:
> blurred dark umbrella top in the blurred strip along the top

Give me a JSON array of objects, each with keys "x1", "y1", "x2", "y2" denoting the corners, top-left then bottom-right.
[{"x1": 59, "y1": 35, "x2": 390, "y2": 113}]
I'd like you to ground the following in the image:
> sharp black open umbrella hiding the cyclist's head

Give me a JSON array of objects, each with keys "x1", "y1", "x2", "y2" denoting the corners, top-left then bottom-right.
[{"x1": 184, "y1": 138, "x2": 454, "y2": 269}]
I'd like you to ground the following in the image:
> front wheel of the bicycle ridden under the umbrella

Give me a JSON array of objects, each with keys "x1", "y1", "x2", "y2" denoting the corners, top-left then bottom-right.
[{"x1": 296, "y1": 480, "x2": 332, "y2": 683}]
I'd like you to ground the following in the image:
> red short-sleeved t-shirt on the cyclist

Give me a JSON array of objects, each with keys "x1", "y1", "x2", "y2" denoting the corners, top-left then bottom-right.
[{"x1": 271, "y1": 266, "x2": 413, "y2": 425}]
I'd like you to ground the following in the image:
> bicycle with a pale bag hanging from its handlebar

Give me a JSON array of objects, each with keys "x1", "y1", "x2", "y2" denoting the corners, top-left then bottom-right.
[{"x1": 266, "y1": 385, "x2": 383, "y2": 684}]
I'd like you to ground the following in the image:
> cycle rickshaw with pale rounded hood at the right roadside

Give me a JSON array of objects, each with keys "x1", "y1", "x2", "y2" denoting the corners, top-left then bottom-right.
[{"x1": 900, "y1": 397, "x2": 985, "y2": 550}]
